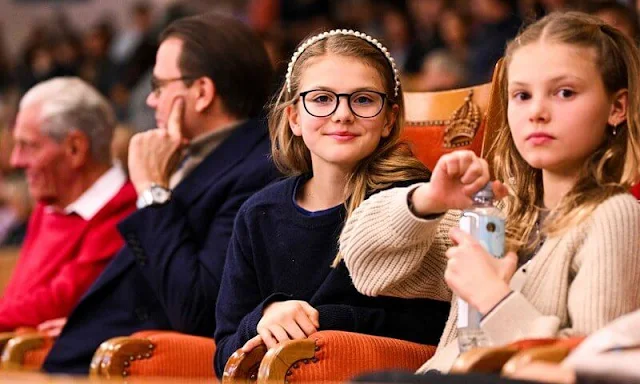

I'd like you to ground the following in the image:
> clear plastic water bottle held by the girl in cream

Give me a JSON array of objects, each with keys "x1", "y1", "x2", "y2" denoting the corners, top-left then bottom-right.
[{"x1": 458, "y1": 183, "x2": 504, "y2": 352}]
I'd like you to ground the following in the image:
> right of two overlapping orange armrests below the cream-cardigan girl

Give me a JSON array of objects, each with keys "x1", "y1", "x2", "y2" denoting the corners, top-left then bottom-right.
[{"x1": 502, "y1": 337, "x2": 584, "y2": 376}]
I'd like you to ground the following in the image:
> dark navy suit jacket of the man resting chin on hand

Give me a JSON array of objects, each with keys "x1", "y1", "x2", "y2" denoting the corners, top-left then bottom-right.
[{"x1": 43, "y1": 120, "x2": 278, "y2": 374}]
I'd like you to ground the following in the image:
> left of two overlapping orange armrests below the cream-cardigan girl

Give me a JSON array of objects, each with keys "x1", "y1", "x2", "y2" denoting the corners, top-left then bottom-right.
[{"x1": 451, "y1": 338, "x2": 558, "y2": 373}]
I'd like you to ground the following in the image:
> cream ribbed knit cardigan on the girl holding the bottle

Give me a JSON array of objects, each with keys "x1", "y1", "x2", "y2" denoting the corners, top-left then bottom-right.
[{"x1": 340, "y1": 184, "x2": 640, "y2": 372}]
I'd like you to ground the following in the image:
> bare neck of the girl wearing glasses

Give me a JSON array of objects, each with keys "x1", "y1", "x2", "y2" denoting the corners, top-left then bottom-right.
[{"x1": 296, "y1": 161, "x2": 350, "y2": 212}]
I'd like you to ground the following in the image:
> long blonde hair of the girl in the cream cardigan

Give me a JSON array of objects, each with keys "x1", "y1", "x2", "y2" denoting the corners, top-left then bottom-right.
[{"x1": 490, "y1": 12, "x2": 640, "y2": 252}]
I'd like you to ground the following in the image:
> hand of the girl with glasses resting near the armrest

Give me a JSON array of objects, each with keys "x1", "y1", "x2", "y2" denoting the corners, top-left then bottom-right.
[{"x1": 257, "y1": 300, "x2": 320, "y2": 349}]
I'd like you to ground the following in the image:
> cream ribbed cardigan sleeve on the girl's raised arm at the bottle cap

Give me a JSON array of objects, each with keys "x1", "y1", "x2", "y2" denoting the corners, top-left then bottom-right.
[{"x1": 340, "y1": 184, "x2": 460, "y2": 301}]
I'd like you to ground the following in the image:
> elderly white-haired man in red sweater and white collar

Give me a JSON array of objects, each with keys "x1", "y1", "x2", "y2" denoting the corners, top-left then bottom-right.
[{"x1": 0, "y1": 78, "x2": 136, "y2": 331}]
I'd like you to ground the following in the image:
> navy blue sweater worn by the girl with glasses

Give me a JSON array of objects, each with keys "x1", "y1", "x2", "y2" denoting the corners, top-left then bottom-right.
[{"x1": 214, "y1": 176, "x2": 449, "y2": 377}]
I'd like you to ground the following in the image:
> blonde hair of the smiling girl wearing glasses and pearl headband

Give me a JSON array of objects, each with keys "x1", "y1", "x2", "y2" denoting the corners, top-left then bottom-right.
[{"x1": 269, "y1": 34, "x2": 429, "y2": 266}]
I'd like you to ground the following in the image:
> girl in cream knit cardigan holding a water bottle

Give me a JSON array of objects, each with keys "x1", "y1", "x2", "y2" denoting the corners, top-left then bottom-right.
[{"x1": 340, "y1": 13, "x2": 640, "y2": 371}]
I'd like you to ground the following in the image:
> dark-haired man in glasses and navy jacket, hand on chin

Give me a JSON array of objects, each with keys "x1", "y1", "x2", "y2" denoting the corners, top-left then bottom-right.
[{"x1": 44, "y1": 14, "x2": 277, "y2": 373}]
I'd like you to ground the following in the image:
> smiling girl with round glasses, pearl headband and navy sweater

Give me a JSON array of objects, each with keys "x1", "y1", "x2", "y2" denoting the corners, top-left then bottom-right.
[{"x1": 215, "y1": 30, "x2": 449, "y2": 375}]
